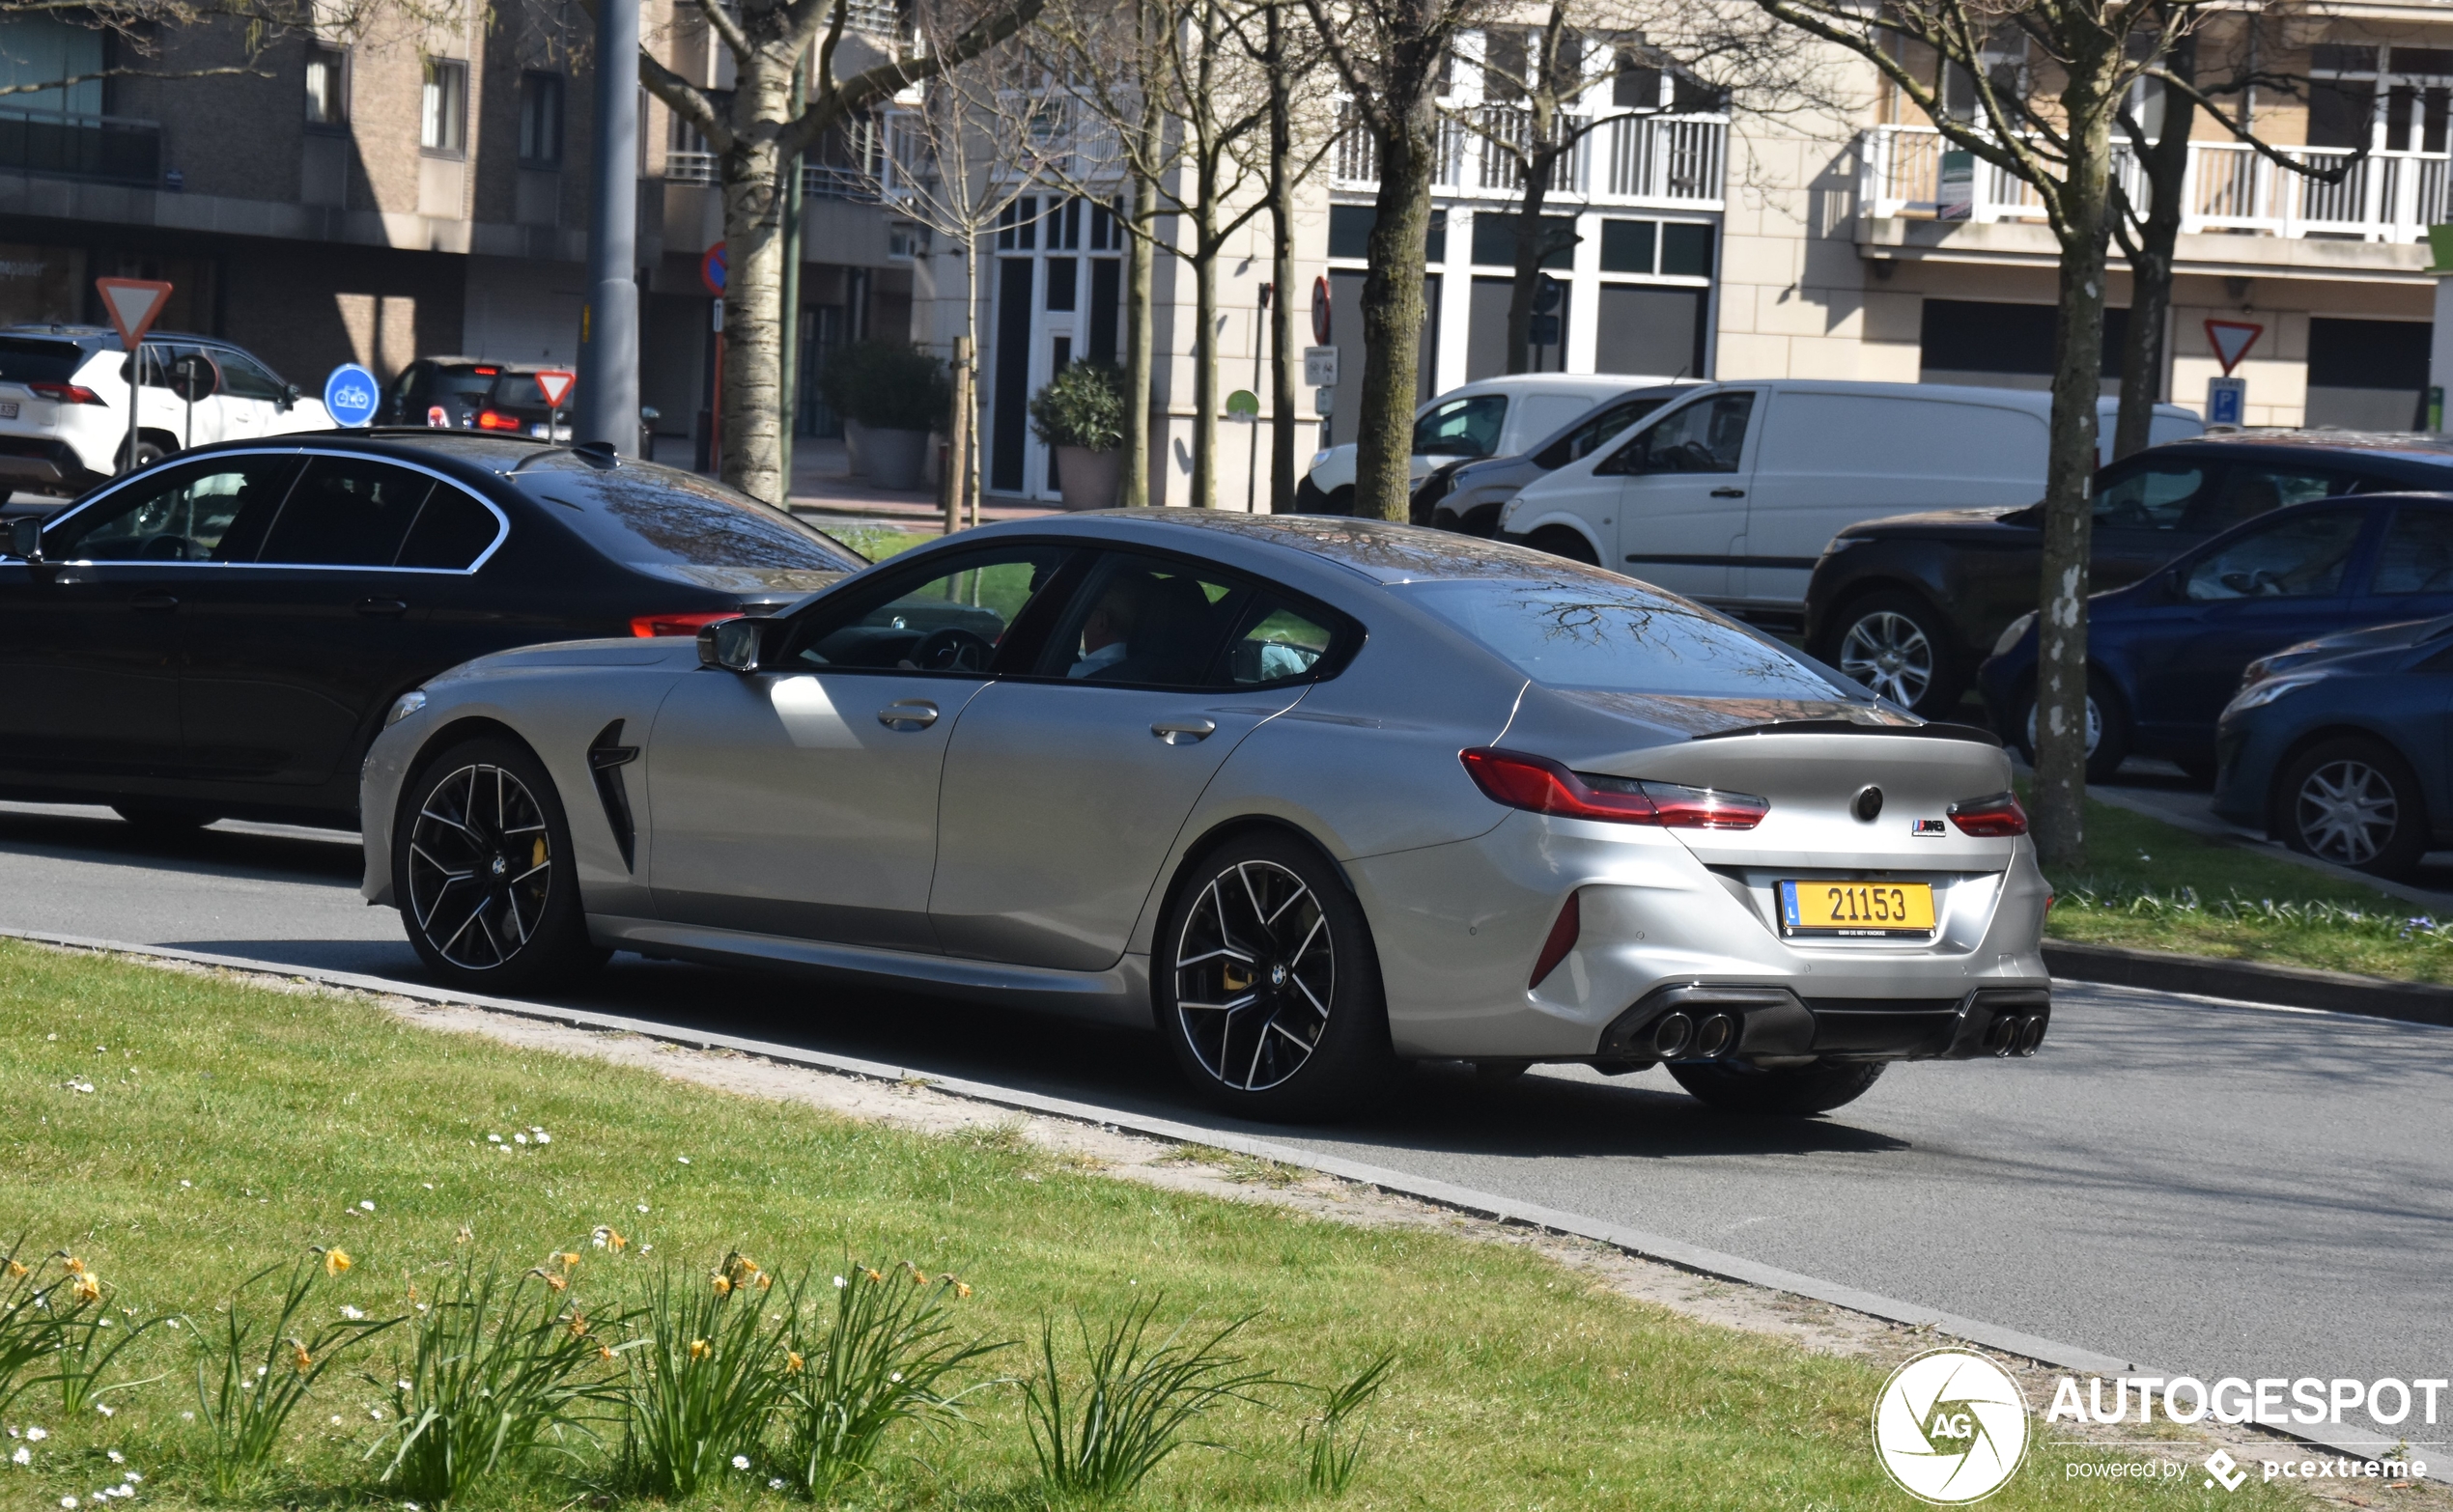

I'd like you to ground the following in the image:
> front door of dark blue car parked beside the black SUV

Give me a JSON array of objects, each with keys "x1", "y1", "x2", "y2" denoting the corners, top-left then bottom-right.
[{"x1": 2122, "y1": 505, "x2": 2375, "y2": 747}]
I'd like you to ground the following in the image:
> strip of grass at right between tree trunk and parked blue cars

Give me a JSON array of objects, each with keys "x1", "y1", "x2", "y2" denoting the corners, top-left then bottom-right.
[{"x1": 2044, "y1": 801, "x2": 2453, "y2": 983}]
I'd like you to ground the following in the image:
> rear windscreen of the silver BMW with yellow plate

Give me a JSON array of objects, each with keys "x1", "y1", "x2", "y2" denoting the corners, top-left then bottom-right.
[{"x1": 1396, "y1": 571, "x2": 1867, "y2": 701}]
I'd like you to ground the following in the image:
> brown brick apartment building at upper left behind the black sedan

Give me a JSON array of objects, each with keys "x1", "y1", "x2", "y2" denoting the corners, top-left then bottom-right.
[{"x1": 0, "y1": 0, "x2": 910, "y2": 438}]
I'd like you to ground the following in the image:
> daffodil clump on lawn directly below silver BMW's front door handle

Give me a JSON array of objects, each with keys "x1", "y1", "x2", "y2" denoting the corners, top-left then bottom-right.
[{"x1": 785, "y1": 1262, "x2": 1010, "y2": 1499}]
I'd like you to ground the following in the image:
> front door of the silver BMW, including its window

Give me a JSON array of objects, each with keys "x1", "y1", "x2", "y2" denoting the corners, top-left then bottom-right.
[{"x1": 645, "y1": 542, "x2": 1077, "y2": 953}]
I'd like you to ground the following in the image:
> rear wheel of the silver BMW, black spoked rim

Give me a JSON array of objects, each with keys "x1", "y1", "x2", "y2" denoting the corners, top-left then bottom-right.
[{"x1": 1150, "y1": 833, "x2": 1396, "y2": 1122}]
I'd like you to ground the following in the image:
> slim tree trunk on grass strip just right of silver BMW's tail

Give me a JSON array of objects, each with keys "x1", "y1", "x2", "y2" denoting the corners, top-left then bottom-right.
[{"x1": 2034, "y1": 44, "x2": 2120, "y2": 867}]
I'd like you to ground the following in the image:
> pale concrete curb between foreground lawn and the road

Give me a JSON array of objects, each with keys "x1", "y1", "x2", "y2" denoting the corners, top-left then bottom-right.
[{"x1": 0, "y1": 929, "x2": 2389, "y2": 1458}]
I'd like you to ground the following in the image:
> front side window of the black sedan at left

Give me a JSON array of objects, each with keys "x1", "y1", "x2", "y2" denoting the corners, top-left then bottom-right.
[{"x1": 42, "y1": 454, "x2": 299, "y2": 561}]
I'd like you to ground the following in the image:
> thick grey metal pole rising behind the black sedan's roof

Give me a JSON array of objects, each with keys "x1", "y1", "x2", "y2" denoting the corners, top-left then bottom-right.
[{"x1": 572, "y1": 0, "x2": 640, "y2": 456}]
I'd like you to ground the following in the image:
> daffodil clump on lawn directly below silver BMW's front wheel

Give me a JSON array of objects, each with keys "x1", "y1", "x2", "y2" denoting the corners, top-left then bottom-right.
[{"x1": 365, "y1": 1252, "x2": 631, "y2": 1502}]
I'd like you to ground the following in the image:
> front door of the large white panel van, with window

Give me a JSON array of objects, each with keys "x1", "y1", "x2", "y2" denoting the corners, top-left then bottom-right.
[{"x1": 1592, "y1": 390, "x2": 1766, "y2": 601}]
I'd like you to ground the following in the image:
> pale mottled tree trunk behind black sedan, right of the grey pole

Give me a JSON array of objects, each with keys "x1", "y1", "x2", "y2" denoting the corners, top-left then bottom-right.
[{"x1": 719, "y1": 127, "x2": 785, "y2": 505}]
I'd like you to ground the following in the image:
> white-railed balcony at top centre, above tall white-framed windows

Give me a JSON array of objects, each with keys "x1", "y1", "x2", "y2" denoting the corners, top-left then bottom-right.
[{"x1": 1330, "y1": 105, "x2": 1730, "y2": 210}]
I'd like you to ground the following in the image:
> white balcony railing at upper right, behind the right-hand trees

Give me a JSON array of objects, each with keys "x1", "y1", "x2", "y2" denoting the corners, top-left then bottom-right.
[{"x1": 1859, "y1": 125, "x2": 2453, "y2": 242}]
